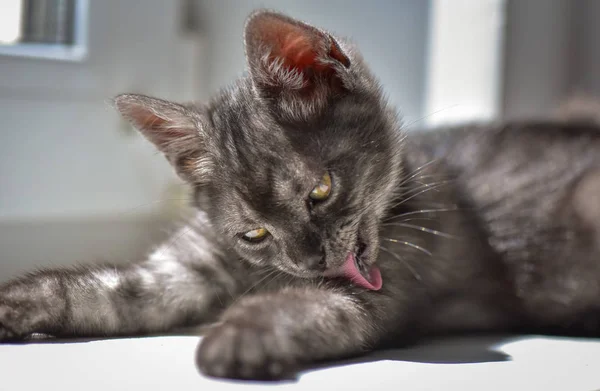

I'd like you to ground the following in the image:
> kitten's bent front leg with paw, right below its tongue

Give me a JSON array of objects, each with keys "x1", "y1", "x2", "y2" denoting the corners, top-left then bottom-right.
[{"x1": 197, "y1": 288, "x2": 385, "y2": 379}]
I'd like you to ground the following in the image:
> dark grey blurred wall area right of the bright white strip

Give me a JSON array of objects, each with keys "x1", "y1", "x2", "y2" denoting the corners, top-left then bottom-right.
[{"x1": 503, "y1": 0, "x2": 600, "y2": 118}]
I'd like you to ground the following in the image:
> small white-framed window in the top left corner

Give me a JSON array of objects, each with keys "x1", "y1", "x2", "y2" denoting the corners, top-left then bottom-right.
[{"x1": 0, "y1": 0, "x2": 87, "y2": 61}]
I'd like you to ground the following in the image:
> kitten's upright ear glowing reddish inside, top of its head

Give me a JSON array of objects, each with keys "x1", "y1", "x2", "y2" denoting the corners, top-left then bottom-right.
[{"x1": 245, "y1": 11, "x2": 350, "y2": 118}]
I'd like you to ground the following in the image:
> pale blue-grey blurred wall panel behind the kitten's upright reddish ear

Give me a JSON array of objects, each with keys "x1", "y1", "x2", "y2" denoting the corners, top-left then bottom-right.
[{"x1": 198, "y1": 0, "x2": 430, "y2": 122}]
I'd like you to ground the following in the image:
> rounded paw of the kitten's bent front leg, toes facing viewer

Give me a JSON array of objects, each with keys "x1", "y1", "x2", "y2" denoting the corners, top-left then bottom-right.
[{"x1": 196, "y1": 320, "x2": 298, "y2": 380}]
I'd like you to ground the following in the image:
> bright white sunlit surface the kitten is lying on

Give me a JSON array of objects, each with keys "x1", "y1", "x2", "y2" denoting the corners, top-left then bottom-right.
[{"x1": 0, "y1": 336, "x2": 600, "y2": 391}]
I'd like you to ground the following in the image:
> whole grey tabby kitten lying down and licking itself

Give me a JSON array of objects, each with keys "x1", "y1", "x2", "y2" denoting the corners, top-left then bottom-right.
[{"x1": 0, "y1": 11, "x2": 600, "y2": 379}]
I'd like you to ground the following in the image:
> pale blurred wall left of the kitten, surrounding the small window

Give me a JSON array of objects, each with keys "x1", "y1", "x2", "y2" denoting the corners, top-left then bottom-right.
[{"x1": 0, "y1": 0, "x2": 201, "y2": 281}]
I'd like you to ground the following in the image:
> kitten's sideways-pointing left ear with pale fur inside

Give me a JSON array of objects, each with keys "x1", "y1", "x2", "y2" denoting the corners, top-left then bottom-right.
[{"x1": 113, "y1": 94, "x2": 211, "y2": 182}]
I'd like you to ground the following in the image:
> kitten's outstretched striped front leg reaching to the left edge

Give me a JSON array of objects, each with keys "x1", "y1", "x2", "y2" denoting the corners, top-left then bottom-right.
[{"x1": 0, "y1": 239, "x2": 244, "y2": 340}]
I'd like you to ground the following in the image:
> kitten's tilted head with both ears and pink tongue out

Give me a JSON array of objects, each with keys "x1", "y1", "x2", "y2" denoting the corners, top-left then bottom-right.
[{"x1": 115, "y1": 11, "x2": 402, "y2": 289}]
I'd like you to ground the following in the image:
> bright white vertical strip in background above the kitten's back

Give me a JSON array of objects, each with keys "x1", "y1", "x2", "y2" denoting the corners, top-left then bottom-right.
[{"x1": 423, "y1": 0, "x2": 508, "y2": 128}]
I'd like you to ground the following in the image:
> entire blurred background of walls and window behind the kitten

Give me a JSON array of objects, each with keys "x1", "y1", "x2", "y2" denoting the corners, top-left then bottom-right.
[{"x1": 0, "y1": 0, "x2": 600, "y2": 280}]
